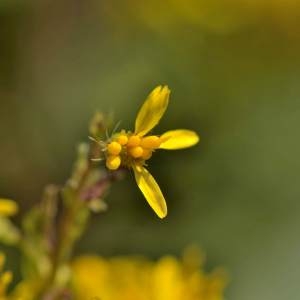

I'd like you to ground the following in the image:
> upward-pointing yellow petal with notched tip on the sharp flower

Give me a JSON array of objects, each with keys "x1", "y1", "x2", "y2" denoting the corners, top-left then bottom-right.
[{"x1": 135, "y1": 86, "x2": 170, "y2": 136}]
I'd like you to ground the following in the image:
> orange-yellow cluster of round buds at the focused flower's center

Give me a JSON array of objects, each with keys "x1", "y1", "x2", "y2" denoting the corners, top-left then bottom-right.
[{"x1": 106, "y1": 131, "x2": 161, "y2": 170}]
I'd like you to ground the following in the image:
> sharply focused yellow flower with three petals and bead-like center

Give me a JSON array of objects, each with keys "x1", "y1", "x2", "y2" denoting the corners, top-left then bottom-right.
[{"x1": 105, "y1": 86, "x2": 199, "y2": 218}]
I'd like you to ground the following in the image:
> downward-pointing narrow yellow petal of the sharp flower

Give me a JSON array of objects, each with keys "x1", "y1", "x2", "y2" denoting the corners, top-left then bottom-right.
[{"x1": 133, "y1": 166, "x2": 167, "y2": 218}]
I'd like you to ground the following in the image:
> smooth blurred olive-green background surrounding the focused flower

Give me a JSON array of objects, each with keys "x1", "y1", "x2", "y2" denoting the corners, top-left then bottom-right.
[{"x1": 0, "y1": 0, "x2": 300, "y2": 300}]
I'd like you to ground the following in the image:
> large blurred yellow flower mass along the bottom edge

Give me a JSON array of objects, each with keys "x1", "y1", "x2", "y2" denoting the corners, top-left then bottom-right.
[{"x1": 72, "y1": 248, "x2": 228, "y2": 300}]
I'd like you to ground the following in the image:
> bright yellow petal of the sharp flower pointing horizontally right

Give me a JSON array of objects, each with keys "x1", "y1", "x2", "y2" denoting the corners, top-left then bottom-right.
[{"x1": 159, "y1": 129, "x2": 200, "y2": 150}]
